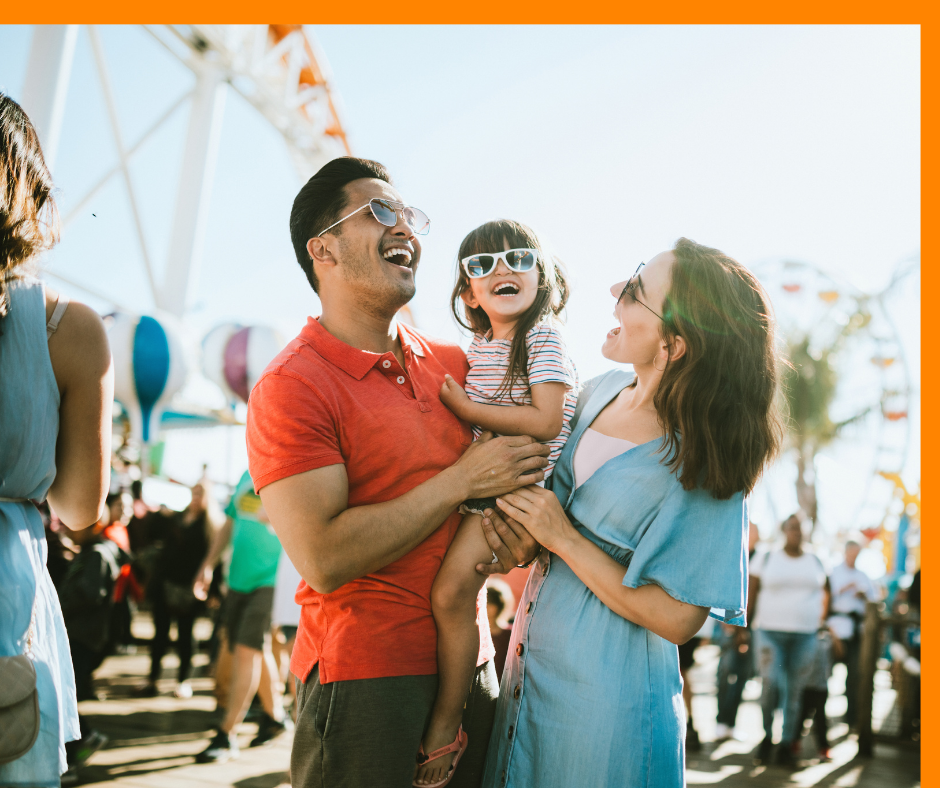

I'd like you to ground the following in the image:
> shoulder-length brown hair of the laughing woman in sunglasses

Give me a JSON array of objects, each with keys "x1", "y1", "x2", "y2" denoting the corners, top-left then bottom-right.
[{"x1": 654, "y1": 238, "x2": 783, "y2": 499}]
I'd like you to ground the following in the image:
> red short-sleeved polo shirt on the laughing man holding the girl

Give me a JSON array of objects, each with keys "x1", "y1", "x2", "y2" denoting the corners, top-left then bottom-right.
[{"x1": 246, "y1": 318, "x2": 494, "y2": 684}]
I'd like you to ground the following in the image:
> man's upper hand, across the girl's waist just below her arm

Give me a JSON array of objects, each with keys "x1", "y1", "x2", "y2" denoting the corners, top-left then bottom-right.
[{"x1": 452, "y1": 432, "x2": 551, "y2": 499}]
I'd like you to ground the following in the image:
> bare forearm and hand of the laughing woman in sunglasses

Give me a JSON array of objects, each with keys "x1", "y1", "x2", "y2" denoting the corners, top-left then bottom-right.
[{"x1": 494, "y1": 487, "x2": 708, "y2": 644}]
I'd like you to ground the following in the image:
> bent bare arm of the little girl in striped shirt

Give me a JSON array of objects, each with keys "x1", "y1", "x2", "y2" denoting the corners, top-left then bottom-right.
[{"x1": 441, "y1": 375, "x2": 565, "y2": 441}]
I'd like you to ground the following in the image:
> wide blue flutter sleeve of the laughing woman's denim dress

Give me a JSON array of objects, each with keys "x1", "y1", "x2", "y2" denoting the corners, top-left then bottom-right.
[{"x1": 623, "y1": 484, "x2": 748, "y2": 626}]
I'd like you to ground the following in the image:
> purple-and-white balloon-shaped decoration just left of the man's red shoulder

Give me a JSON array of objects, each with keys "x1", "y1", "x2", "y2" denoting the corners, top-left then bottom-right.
[{"x1": 202, "y1": 323, "x2": 285, "y2": 403}]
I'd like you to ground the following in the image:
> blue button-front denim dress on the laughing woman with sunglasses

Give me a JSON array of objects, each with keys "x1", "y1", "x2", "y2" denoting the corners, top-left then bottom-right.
[{"x1": 483, "y1": 371, "x2": 748, "y2": 788}]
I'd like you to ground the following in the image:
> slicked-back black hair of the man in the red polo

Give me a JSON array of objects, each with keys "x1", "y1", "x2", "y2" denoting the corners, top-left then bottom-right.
[{"x1": 290, "y1": 156, "x2": 392, "y2": 293}]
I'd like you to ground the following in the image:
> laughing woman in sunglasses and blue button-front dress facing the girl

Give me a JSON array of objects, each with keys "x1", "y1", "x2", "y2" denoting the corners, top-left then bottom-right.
[{"x1": 483, "y1": 239, "x2": 782, "y2": 788}]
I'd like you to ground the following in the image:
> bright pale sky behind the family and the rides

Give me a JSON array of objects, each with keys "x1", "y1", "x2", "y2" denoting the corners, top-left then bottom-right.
[{"x1": 0, "y1": 21, "x2": 920, "y2": 556}]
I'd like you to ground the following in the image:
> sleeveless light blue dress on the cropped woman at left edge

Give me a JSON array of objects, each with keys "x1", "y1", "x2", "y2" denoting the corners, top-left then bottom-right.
[{"x1": 0, "y1": 279, "x2": 79, "y2": 788}]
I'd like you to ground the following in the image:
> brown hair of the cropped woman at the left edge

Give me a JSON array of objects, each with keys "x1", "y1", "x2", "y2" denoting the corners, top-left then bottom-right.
[{"x1": 0, "y1": 93, "x2": 59, "y2": 327}]
